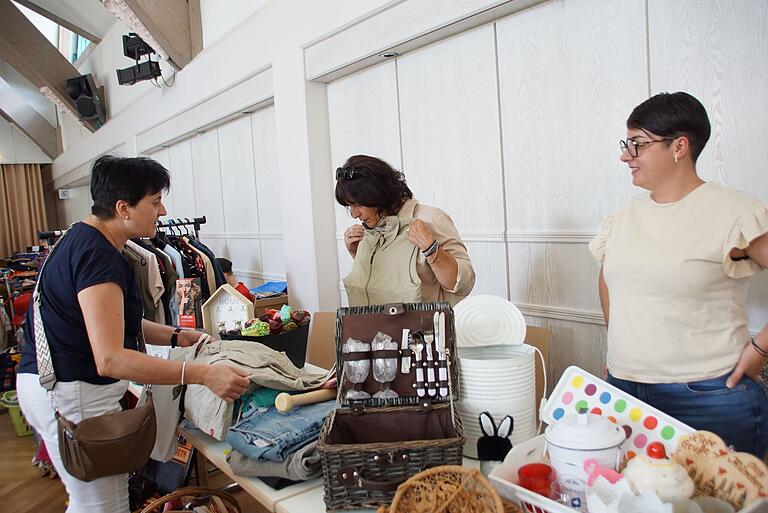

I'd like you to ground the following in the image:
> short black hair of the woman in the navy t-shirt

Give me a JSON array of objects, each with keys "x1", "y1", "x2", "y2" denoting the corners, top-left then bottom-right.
[{"x1": 91, "y1": 155, "x2": 171, "y2": 219}]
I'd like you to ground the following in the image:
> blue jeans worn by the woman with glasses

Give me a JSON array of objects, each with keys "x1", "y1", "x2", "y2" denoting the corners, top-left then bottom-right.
[{"x1": 608, "y1": 373, "x2": 768, "y2": 459}]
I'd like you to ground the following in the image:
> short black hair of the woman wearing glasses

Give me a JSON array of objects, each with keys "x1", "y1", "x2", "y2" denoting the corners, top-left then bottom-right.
[{"x1": 627, "y1": 91, "x2": 712, "y2": 162}]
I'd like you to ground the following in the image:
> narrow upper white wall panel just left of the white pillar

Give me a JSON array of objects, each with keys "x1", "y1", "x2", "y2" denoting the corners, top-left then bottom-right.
[{"x1": 250, "y1": 106, "x2": 282, "y2": 233}]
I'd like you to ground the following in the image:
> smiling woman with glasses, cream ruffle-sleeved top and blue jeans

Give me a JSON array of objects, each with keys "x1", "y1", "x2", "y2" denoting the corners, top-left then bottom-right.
[{"x1": 590, "y1": 92, "x2": 768, "y2": 457}]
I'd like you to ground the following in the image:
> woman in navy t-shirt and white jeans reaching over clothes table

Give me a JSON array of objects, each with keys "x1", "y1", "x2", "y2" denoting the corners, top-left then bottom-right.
[{"x1": 17, "y1": 156, "x2": 249, "y2": 513}]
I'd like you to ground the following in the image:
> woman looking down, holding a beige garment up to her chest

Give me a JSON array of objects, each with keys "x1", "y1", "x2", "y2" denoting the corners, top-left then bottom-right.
[{"x1": 336, "y1": 155, "x2": 475, "y2": 306}]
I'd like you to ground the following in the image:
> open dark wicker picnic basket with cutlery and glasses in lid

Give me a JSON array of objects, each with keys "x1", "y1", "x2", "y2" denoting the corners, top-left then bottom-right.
[{"x1": 318, "y1": 303, "x2": 465, "y2": 511}]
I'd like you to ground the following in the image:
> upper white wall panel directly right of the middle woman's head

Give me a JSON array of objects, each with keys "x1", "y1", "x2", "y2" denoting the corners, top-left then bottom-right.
[{"x1": 398, "y1": 25, "x2": 504, "y2": 232}]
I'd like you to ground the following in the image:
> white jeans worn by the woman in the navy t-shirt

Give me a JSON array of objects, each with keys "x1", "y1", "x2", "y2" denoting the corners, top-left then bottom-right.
[{"x1": 16, "y1": 374, "x2": 129, "y2": 513}]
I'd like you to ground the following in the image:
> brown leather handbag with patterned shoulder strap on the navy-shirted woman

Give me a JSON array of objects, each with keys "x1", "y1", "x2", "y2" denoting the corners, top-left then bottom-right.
[{"x1": 33, "y1": 223, "x2": 157, "y2": 481}]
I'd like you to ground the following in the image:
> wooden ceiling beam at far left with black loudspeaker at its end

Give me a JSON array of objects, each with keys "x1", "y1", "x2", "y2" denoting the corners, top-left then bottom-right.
[{"x1": 0, "y1": 0, "x2": 100, "y2": 132}]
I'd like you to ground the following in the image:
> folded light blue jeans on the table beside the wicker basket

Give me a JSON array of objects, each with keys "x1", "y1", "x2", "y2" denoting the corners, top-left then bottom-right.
[{"x1": 226, "y1": 401, "x2": 336, "y2": 462}]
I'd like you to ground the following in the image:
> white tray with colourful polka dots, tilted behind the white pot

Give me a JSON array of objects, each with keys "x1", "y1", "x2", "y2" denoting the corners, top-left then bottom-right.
[{"x1": 541, "y1": 367, "x2": 694, "y2": 457}]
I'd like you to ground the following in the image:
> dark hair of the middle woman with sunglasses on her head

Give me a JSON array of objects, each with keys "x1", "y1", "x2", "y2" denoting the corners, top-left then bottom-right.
[{"x1": 336, "y1": 155, "x2": 413, "y2": 215}]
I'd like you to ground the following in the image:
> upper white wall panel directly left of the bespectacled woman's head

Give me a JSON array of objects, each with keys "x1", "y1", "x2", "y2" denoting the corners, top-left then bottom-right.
[{"x1": 497, "y1": 0, "x2": 647, "y2": 230}]
